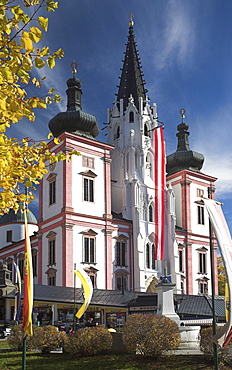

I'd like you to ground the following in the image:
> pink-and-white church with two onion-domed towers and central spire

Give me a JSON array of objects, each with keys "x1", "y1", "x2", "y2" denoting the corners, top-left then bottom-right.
[{"x1": 0, "y1": 21, "x2": 217, "y2": 295}]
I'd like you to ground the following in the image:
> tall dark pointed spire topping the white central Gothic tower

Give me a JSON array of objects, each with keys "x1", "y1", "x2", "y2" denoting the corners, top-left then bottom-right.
[{"x1": 117, "y1": 14, "x2": 147, "y2": 111}]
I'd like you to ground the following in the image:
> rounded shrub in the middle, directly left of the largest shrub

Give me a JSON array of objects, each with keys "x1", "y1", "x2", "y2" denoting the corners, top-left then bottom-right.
[{"x1": 64, "y1": 327, "x2": 112, "y2": 356}]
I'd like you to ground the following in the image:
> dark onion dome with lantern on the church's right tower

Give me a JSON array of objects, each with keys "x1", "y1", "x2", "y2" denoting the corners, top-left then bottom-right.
[{"x1": 166, "y1": 109, "x2": 204, "y2": 176}]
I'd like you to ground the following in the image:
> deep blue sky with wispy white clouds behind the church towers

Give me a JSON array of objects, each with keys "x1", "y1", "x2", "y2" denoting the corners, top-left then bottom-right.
[{"x1": 8, "y1": 0, "x2": 232, "y2": 230}]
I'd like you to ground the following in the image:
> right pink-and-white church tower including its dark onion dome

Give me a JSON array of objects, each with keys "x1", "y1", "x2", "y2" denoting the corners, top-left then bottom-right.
[{"x1": 167, "y1": 110, "x2": 218, "y2": 294}]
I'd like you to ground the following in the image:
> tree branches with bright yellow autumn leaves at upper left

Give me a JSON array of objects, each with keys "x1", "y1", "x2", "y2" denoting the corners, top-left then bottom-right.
[{"x1": 0, "y1": 0, "x2": 78, "y2": 215}]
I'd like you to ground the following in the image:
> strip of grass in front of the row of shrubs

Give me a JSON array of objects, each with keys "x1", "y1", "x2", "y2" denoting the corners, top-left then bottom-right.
[{"x1": 0, "y1": 341, "x2": 231, "y2": 370}]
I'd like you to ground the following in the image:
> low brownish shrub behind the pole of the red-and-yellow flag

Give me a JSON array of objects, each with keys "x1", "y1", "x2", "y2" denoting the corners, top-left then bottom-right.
[{"x1": 7, "y1": 325, "x2": 66, "y2": 353}]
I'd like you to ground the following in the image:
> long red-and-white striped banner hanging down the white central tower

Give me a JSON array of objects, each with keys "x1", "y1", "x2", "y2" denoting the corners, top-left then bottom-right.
[{"x1": 154, "y1": 126, "x2": 166, "y2": 260}]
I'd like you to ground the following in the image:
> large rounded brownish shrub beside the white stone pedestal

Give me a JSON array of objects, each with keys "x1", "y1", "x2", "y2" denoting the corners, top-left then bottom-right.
[{"x1": 123, "y1": 314, "x2": 180, "y2": 357}]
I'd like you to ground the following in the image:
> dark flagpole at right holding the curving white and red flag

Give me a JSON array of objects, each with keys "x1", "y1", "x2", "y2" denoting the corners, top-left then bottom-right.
[{"x1": 208, "y1": 187, "x2": 218, "y2": 370}]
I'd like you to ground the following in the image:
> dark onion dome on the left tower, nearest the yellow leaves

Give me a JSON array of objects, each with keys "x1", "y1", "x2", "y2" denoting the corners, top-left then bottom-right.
[{"x1": 48, "y1": 62, "x2": 99, "y2": 139}]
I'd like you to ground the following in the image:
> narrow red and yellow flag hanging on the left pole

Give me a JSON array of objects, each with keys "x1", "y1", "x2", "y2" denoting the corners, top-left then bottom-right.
[{"x1": 23, "y1": 210, "x2": 33, "y2": 335}]
